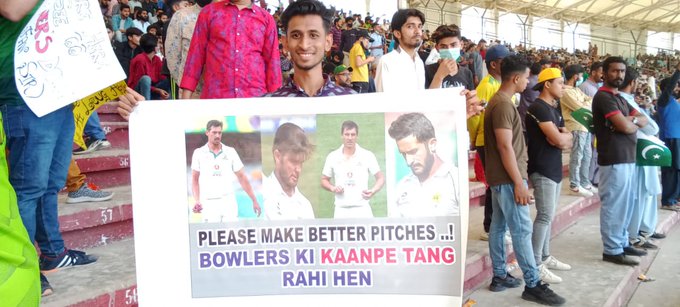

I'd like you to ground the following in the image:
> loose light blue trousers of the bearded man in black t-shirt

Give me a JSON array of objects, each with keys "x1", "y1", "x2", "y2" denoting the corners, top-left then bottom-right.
[{"x1": 599, "y1": 163, "x2": 636, "y2": 255}]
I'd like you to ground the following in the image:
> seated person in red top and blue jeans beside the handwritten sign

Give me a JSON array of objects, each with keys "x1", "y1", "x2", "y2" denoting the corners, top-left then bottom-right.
[{"x1": 128, "y1": 34, "x2": 170, "y2": 100}]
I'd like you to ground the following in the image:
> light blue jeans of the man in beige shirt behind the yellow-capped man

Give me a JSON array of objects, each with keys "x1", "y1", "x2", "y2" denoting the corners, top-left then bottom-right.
[{"x1": 569, "y1": 131, "x2": 593, "y2": 188}]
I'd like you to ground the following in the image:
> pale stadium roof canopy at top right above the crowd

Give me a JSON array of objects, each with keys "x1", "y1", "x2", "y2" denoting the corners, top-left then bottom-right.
[{"x1": 408, "y1": 0, "x2": 680, "y2": 32}]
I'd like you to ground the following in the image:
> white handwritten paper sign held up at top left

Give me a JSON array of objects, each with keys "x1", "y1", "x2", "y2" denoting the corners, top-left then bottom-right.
[{"x1": 14, "y1": 0, "x2": 125, "y2": 116}]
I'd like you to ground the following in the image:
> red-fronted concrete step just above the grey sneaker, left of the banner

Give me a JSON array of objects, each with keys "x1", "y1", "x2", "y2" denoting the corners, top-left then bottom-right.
[{"x1": 73, "y1": 148, "x2": 130, "y2": 188}]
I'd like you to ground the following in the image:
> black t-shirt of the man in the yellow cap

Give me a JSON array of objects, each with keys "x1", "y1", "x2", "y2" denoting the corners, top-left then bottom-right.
[{"x1": 525, "y1": 98, "x2": 564, "y2": 183}]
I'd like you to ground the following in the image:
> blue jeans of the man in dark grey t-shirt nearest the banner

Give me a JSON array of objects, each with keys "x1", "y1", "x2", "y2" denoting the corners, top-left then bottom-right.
[{"x1": 489, "y1": 182, "x2": 539, "y2": 288}]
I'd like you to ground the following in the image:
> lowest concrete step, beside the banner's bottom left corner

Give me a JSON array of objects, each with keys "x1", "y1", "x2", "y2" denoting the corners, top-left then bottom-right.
[{"x1": 41, "y1": 239, "x2": 137, "y2": 307}]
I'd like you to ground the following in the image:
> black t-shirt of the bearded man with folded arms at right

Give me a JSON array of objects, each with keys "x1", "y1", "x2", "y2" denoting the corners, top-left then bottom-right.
[{"x1": 593, "y1": 88, "x2": 637, "y2": 165}]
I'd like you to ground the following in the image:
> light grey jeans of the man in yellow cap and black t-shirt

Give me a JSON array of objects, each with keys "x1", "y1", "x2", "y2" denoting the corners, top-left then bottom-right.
[{"x1": 529, "y1": 173, "x2": 562, "y2": 264}]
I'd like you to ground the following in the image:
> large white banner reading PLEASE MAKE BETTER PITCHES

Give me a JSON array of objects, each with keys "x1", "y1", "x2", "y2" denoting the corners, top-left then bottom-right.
[{"x1": 130, "y1": 89, "x2": 469, "y2": 306}]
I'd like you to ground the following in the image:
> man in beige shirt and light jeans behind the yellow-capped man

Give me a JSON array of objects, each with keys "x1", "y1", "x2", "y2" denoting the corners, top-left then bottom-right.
[{"x1": 560, "y1": 64, "x2": 597, "y2": 197}]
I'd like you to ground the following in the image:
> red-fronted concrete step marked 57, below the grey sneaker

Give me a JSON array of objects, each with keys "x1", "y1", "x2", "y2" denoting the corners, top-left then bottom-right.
[{"x1": 59, "y1": 186, "x2": 133, "y2": 249}]
